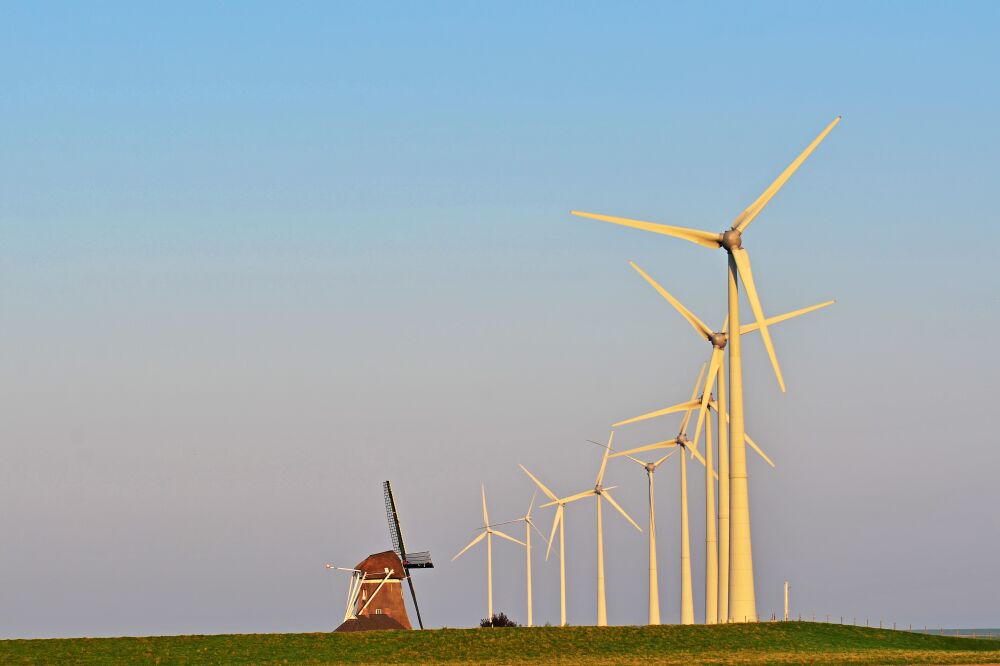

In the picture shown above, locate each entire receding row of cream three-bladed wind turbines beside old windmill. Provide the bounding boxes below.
[453,116,840,626]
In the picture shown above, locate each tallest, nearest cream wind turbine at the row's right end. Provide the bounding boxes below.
[571,116,840,622]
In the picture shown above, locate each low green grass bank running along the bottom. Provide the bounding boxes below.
[0,622,1000,664]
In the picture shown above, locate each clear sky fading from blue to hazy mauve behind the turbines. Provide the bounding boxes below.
[0,2,1000,638]
